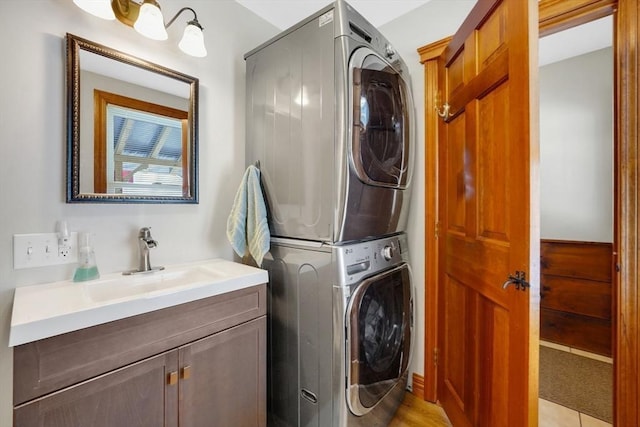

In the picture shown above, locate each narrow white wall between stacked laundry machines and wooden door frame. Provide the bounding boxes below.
[380,0,476,388]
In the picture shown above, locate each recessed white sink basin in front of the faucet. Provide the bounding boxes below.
[84,266,226,303]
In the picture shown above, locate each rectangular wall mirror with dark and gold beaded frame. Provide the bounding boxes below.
[66,34,198,203]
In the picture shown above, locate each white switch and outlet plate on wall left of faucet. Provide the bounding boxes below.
[13,232,78,270]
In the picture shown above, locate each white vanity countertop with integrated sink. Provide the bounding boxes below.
[9,259,269,347]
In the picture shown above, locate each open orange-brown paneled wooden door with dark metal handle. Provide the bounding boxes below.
[438,0,539,427]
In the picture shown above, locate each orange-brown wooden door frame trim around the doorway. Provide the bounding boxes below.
[418,0,640,426]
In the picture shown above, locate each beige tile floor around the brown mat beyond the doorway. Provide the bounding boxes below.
[538,341,613,427]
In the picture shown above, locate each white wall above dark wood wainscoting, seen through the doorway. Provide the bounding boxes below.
[540,48,613,242]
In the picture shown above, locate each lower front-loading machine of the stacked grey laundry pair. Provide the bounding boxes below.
[264,234,413,427]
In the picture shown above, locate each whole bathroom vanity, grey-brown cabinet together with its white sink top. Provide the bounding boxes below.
[10,260,268,427]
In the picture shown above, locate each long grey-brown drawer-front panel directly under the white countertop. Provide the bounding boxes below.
[13,285,266,406]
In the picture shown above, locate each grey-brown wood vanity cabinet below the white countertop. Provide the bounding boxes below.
[14,285,266,427]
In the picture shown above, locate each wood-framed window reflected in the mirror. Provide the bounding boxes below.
[94,90,189,197]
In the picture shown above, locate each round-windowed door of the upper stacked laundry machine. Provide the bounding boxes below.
[349,48,413,189]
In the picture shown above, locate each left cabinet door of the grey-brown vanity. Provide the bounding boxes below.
[14,351,178,427]
